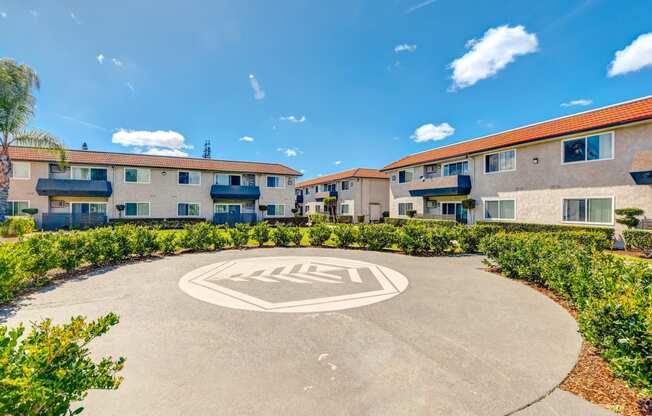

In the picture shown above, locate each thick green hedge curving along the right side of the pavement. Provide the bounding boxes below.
[480,233,652,394]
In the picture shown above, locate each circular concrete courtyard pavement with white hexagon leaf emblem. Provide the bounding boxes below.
[0,248,581,416]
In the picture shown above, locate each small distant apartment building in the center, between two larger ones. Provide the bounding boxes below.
[296,168,389,222]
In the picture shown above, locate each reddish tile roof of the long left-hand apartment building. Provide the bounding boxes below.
[9,146,301,176]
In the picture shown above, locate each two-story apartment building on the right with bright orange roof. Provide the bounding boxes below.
[382,97,652,237]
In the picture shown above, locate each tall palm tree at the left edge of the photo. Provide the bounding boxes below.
[0,58,66,221]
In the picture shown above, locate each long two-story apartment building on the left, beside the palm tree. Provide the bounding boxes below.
[8,147,301,229]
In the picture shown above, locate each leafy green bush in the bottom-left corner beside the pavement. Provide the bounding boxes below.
[0,313,125,415]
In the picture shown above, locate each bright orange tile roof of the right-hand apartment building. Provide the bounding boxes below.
[381,96,652,170]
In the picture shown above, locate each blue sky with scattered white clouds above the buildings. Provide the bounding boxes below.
[0,0,652,178]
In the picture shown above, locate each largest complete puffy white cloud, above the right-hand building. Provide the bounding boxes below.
[449,25,539,89]
